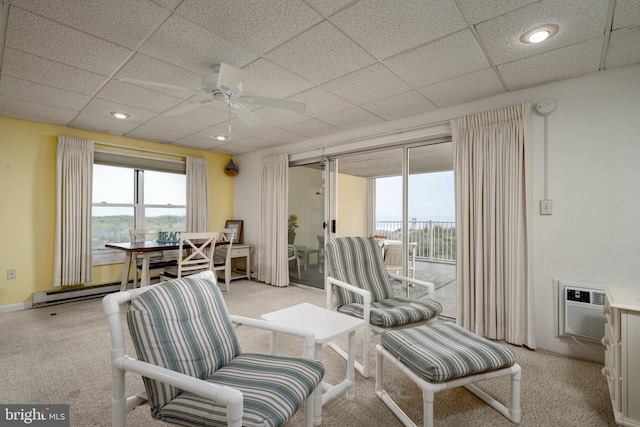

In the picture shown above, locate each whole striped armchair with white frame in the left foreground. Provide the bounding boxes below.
[103,271,324,427]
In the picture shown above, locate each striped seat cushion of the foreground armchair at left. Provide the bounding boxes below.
[159,353,324,427]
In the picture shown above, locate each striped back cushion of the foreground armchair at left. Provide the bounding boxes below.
[127,277,240,416]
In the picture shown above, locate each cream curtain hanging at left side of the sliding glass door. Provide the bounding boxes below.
[258,154,289,287]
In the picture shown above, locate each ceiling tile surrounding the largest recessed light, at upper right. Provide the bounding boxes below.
[477,0,609,65]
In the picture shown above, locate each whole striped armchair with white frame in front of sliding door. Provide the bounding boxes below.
[325,237,442,378]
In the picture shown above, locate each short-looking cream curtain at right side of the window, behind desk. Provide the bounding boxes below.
[187,156,209,233]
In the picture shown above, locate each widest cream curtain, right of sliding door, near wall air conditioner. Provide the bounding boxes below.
[451,103,536,348]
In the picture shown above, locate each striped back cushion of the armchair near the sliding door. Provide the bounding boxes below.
[325,237,393,307]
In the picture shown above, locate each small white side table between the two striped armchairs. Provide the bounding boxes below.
[260,302,364,425]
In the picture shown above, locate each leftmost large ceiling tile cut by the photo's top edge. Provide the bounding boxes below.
[11,0,170,49]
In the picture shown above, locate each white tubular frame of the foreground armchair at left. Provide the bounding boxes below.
[102,271,315,427]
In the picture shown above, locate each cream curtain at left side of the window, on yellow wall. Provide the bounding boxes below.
[53,135,94,286]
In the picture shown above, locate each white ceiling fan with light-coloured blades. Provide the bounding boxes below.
[119,63,306,127]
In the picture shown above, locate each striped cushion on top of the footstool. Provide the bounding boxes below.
[380,323,516,383]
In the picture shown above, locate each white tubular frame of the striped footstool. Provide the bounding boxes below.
[375,344,522,427]
